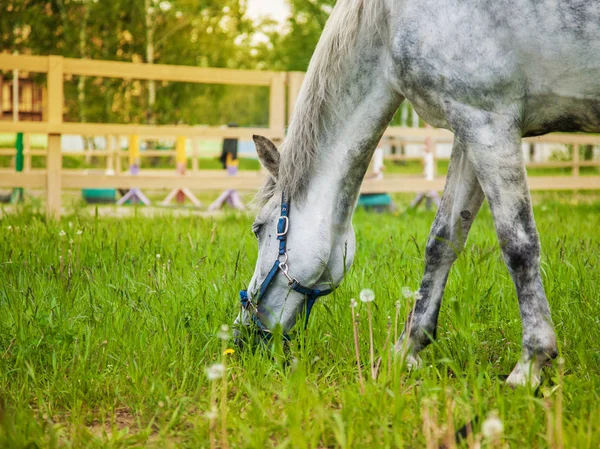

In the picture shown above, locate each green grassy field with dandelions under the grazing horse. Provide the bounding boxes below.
[0,194,600,448]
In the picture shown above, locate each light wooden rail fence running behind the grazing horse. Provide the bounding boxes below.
[0,54,600,217]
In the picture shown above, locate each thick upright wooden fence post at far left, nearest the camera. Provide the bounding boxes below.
[46,56,64,218]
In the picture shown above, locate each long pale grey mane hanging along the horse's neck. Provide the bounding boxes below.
[255,0,386,204]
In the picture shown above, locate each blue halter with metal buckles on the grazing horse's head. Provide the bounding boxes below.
[240,194,333,338]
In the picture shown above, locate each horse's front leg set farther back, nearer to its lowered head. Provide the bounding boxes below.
[396,138,484,367]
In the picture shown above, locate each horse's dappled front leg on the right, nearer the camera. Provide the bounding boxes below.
[467,120,557,386]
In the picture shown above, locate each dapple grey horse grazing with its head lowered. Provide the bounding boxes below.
[236,0,600,385]
